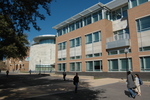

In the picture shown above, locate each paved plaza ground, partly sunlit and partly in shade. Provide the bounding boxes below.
[0,72,150,100]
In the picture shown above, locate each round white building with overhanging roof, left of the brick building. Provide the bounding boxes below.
[29,35,56,73]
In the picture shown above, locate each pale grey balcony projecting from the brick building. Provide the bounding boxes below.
[106,33,130,49]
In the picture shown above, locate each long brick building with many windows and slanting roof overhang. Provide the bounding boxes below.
[53,0,150,76]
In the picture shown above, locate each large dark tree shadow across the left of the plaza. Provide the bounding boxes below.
[0,74,106,100]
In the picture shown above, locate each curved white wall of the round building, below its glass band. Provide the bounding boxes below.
[29,44,55,70]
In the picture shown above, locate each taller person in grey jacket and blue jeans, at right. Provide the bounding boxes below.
[127,71,136,99]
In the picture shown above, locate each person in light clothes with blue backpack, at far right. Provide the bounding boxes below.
[134,74,141,96]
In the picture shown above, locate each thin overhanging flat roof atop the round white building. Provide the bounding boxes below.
[33,35,56,43]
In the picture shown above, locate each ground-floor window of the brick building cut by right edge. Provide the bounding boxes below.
[140,57,150,71]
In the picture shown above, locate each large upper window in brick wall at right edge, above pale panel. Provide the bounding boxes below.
[136,16,150,32]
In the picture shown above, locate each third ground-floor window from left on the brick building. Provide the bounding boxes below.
[86,60,102,72]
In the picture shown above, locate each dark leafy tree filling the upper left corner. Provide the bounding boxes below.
[0,0,52,59]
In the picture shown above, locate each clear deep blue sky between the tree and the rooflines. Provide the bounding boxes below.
[25,0,112,43]
